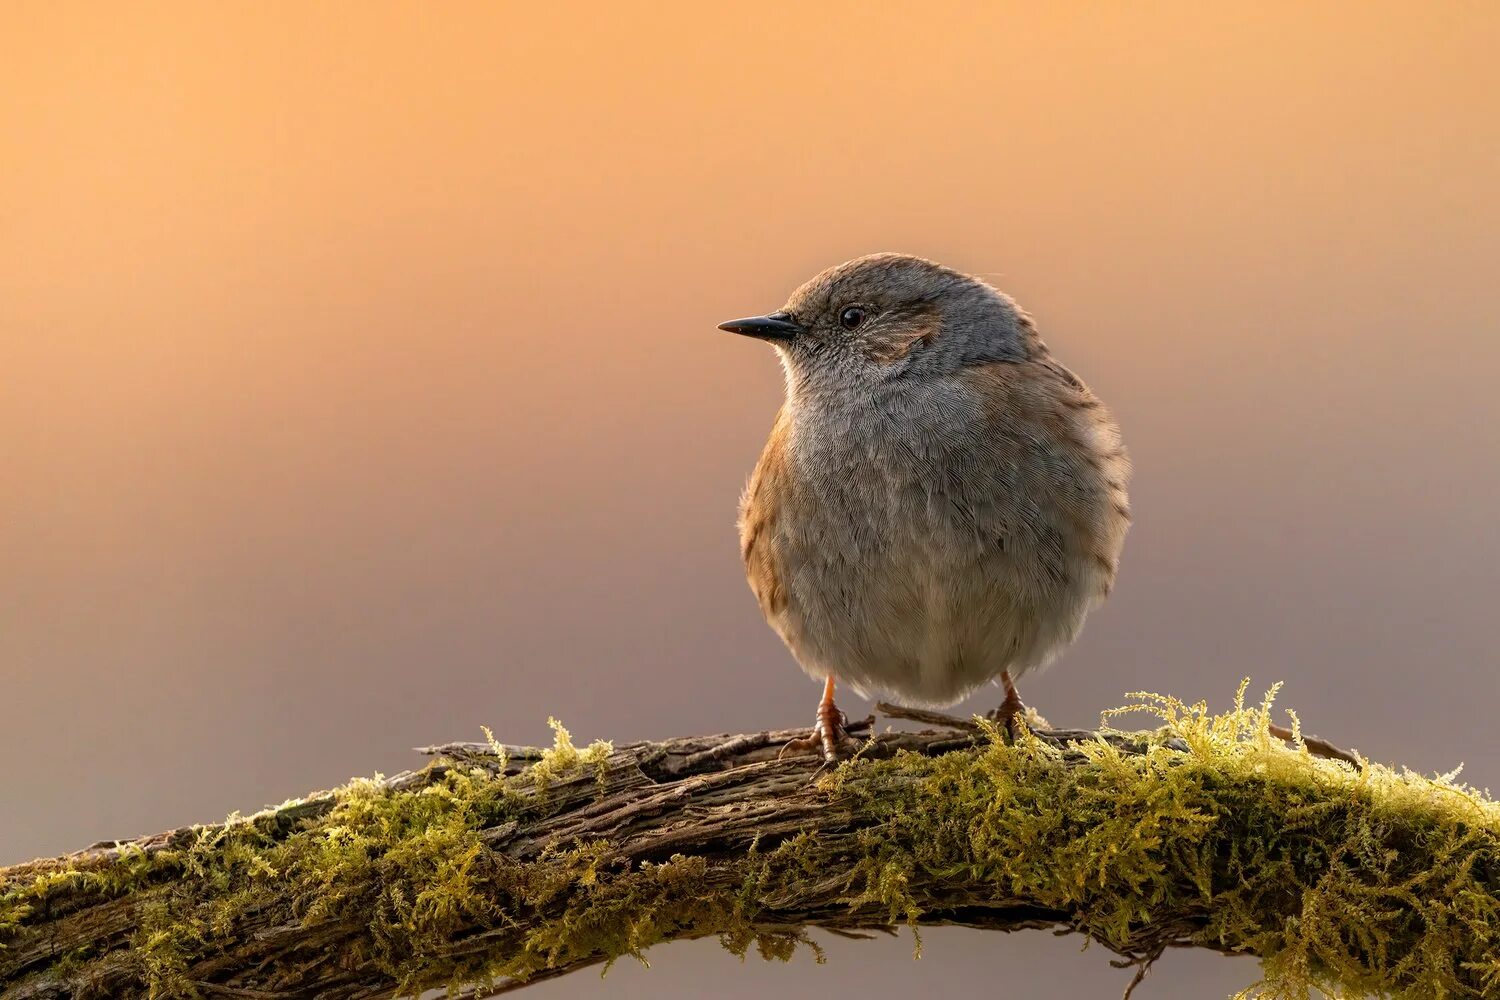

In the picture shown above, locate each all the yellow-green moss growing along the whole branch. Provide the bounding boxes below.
[0,687,1500,1000]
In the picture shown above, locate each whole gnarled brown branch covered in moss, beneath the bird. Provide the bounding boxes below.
[0,688,1500,1000]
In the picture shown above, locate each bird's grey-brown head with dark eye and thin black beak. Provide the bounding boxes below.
[719,253,1038,390]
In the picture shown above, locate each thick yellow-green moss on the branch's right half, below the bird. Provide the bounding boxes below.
[839,683,1500,999]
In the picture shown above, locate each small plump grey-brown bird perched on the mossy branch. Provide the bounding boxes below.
[719,253,1131,762]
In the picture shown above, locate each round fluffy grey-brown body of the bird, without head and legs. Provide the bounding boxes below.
[741,369,1128,705]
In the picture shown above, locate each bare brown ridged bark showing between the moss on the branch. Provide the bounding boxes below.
[0,706,1470,1000]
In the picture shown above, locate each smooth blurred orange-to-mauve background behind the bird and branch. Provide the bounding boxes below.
[0,0,1500,999]
